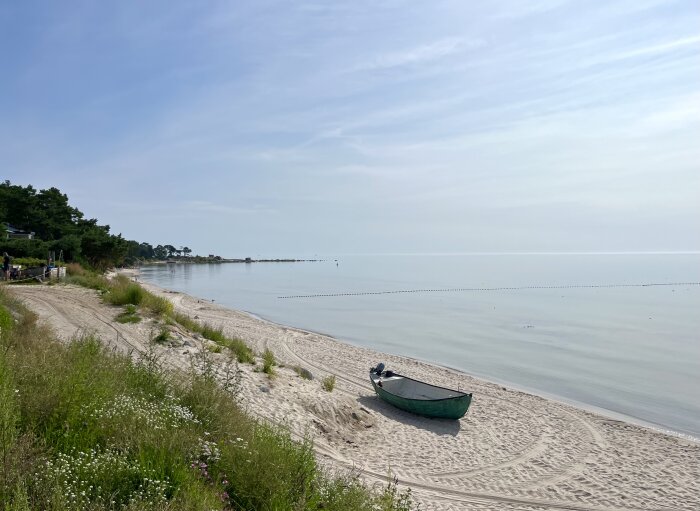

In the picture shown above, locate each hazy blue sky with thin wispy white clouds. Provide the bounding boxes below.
[0,0,700,257]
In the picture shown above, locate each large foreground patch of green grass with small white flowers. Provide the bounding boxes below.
[0,290,410,511]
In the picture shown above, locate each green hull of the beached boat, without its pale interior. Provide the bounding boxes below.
[370,371,472,419]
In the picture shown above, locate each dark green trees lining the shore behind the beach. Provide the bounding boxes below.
[0,181,192,269]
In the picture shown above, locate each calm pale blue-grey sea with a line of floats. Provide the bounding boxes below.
[141,253,700,438]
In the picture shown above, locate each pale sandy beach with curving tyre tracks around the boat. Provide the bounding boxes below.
[13,284,700,511]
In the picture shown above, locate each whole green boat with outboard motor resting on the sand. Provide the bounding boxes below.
[369,364,472,419]
